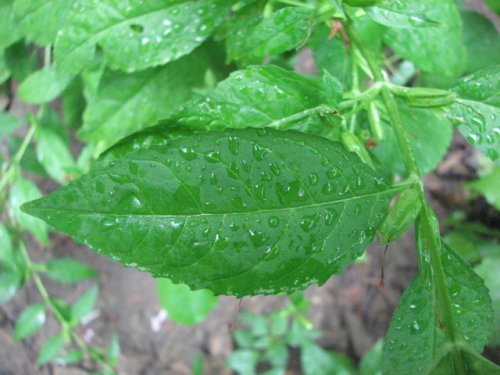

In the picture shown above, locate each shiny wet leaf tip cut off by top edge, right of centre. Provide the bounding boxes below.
[366,0,439,28]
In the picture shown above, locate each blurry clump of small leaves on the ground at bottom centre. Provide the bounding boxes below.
[227,293,355,375]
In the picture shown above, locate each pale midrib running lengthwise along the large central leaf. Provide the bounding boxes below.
[27,186,406,218]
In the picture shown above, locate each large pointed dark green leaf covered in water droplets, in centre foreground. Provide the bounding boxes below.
[23,129,398,296]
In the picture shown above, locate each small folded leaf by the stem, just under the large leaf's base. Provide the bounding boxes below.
[380,188,422,244]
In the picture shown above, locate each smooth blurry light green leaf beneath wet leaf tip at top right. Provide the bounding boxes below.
[384,0,466,77]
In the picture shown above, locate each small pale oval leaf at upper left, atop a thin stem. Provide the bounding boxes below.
[17,65,73,104]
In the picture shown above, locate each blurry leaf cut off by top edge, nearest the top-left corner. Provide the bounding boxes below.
[14,0,71,46]
